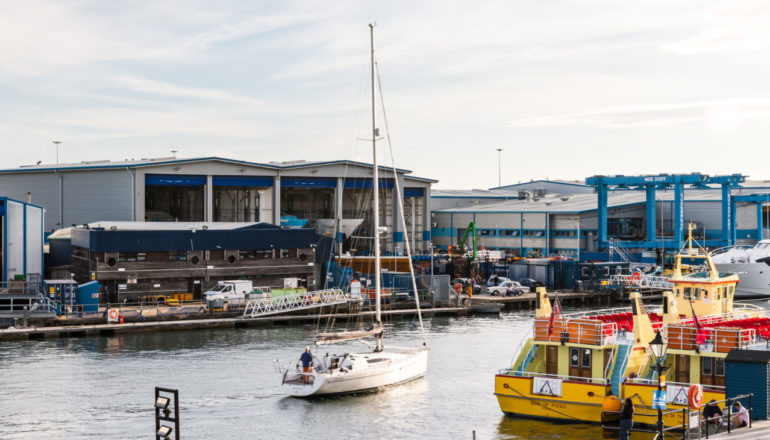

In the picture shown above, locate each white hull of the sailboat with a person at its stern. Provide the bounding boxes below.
[281,347,428,397]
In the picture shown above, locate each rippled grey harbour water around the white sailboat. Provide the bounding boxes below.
[9,300,752,440]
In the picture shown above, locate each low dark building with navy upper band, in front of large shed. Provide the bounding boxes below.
[71,222,331,303]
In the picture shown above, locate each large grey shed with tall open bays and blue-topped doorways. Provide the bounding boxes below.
[0,157,436,253]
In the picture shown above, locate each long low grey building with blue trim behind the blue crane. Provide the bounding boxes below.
[432,174,770,257]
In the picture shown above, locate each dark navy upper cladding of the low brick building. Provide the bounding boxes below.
[72,228,318,252]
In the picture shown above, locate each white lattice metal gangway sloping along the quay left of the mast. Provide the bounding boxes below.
[242,289,350,318]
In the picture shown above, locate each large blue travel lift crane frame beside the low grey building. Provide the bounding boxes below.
[586,173,744,250]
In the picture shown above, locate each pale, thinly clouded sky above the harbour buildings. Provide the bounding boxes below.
[0,0,770,189]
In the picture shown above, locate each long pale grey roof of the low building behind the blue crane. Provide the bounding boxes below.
[439,188,770,213]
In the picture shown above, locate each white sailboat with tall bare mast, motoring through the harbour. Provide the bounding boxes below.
[279,24,428,397]
